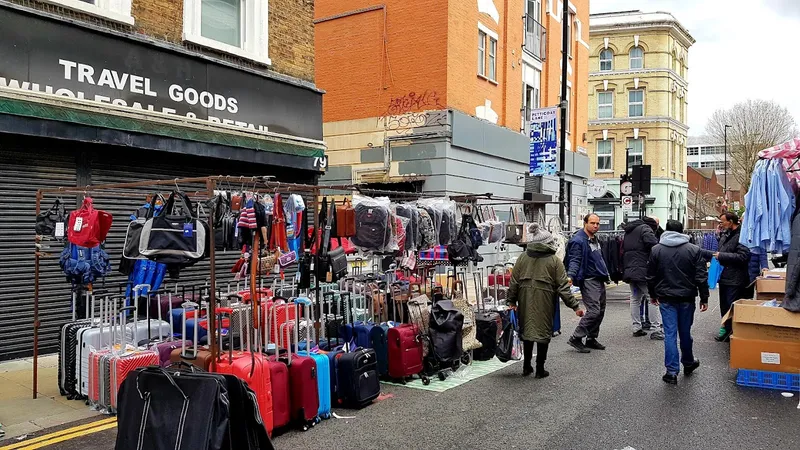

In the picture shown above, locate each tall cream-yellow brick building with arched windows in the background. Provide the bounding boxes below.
[586,11,695,229]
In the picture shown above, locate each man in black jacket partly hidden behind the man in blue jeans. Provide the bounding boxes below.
[622,219,664,339]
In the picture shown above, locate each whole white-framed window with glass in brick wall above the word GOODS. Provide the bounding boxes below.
[183,0,271,64]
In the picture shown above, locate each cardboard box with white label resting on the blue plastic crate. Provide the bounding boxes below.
[730,335,800,373]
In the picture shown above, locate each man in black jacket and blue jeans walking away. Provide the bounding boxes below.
[647,220,708,384]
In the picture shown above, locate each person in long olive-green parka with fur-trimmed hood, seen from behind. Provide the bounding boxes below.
[508,223,583,378]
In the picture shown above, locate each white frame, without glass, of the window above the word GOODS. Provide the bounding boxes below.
[183,0,272,65]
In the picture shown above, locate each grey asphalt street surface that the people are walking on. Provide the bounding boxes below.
[0,287,800,450]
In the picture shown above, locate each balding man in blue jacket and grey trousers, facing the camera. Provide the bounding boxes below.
[565,213,609,353]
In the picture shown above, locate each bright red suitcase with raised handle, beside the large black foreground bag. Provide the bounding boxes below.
[214,304,273,434]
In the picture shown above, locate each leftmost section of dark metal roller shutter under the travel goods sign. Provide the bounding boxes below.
[0,137,77,360]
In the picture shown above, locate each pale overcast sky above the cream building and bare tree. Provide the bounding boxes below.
[590,0,800,136]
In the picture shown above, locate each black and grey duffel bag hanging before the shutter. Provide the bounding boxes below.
[139,192,209,266]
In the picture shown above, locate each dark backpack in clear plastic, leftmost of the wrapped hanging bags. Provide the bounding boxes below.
[350,195,392,253]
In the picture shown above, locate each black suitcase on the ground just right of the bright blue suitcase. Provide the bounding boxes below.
[336,348,381,408]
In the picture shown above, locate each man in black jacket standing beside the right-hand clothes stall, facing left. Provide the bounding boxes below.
[714,212,750,342]
